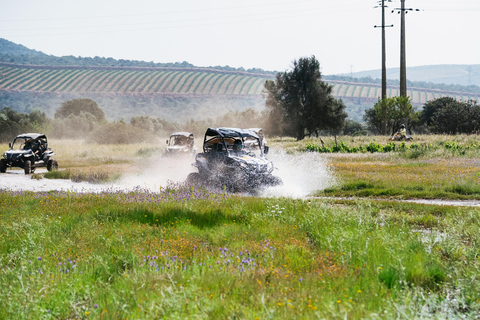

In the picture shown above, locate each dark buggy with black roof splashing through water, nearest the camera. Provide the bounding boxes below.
[186,128,282,192]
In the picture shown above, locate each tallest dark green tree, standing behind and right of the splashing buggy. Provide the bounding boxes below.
[264,56,347,140]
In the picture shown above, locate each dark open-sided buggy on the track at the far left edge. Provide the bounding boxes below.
[0,133,58,174]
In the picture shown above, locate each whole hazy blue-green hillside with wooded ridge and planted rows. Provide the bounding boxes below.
[0,39,480,121]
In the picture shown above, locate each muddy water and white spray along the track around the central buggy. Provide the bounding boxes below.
[0,150,480,207]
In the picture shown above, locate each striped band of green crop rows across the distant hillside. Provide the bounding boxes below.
[0,63,479,105]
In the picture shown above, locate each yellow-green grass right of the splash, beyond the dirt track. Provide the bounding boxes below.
[269,135,480,200]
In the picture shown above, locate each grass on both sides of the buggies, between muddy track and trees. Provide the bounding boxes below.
[0,135,480,200]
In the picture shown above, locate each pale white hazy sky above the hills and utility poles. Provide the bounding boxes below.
[0,0,480,74]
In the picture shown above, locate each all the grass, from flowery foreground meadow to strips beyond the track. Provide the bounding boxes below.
[0,136,480,319]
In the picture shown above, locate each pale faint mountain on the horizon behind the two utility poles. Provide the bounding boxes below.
[341,64,480,86]
